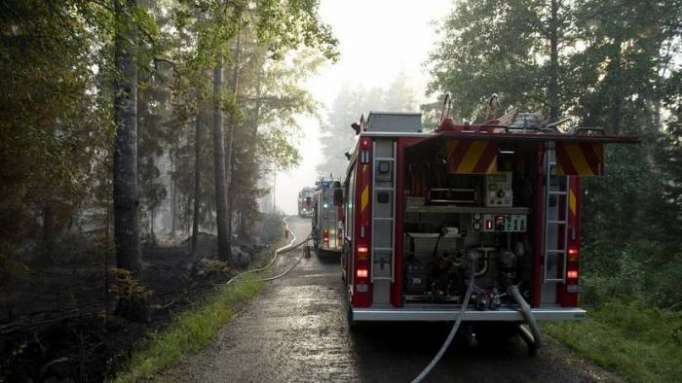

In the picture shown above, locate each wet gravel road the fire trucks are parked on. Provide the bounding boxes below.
[158,218,619,382]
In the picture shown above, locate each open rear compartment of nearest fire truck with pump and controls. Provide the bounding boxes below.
[402,144,537,311]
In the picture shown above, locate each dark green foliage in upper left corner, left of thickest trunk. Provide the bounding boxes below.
[0,1,112,256]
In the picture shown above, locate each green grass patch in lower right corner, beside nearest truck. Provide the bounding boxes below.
[544,301,682,382]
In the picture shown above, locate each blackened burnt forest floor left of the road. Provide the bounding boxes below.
[0,234,266,383]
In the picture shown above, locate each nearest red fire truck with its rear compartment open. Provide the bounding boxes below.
[342,113,638,332]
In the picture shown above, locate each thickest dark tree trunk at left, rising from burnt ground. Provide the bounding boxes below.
[113,0,140,275]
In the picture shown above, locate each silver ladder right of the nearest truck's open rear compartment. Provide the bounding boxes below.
[543,142,568,283]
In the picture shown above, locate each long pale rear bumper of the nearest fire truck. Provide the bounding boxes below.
[351,308,586,322]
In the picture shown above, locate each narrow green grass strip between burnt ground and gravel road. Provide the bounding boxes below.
[114,274,264,383]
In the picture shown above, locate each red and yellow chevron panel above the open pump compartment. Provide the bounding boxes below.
[448,140,497,174]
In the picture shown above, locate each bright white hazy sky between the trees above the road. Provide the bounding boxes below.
[276,0,452,214]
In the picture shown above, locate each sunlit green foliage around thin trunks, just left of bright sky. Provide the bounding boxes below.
[168,0,337,234]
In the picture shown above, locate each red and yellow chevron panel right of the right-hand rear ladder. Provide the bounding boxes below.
[556,142,604,176]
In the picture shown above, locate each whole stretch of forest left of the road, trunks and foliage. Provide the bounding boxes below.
[0,0,338,381]
